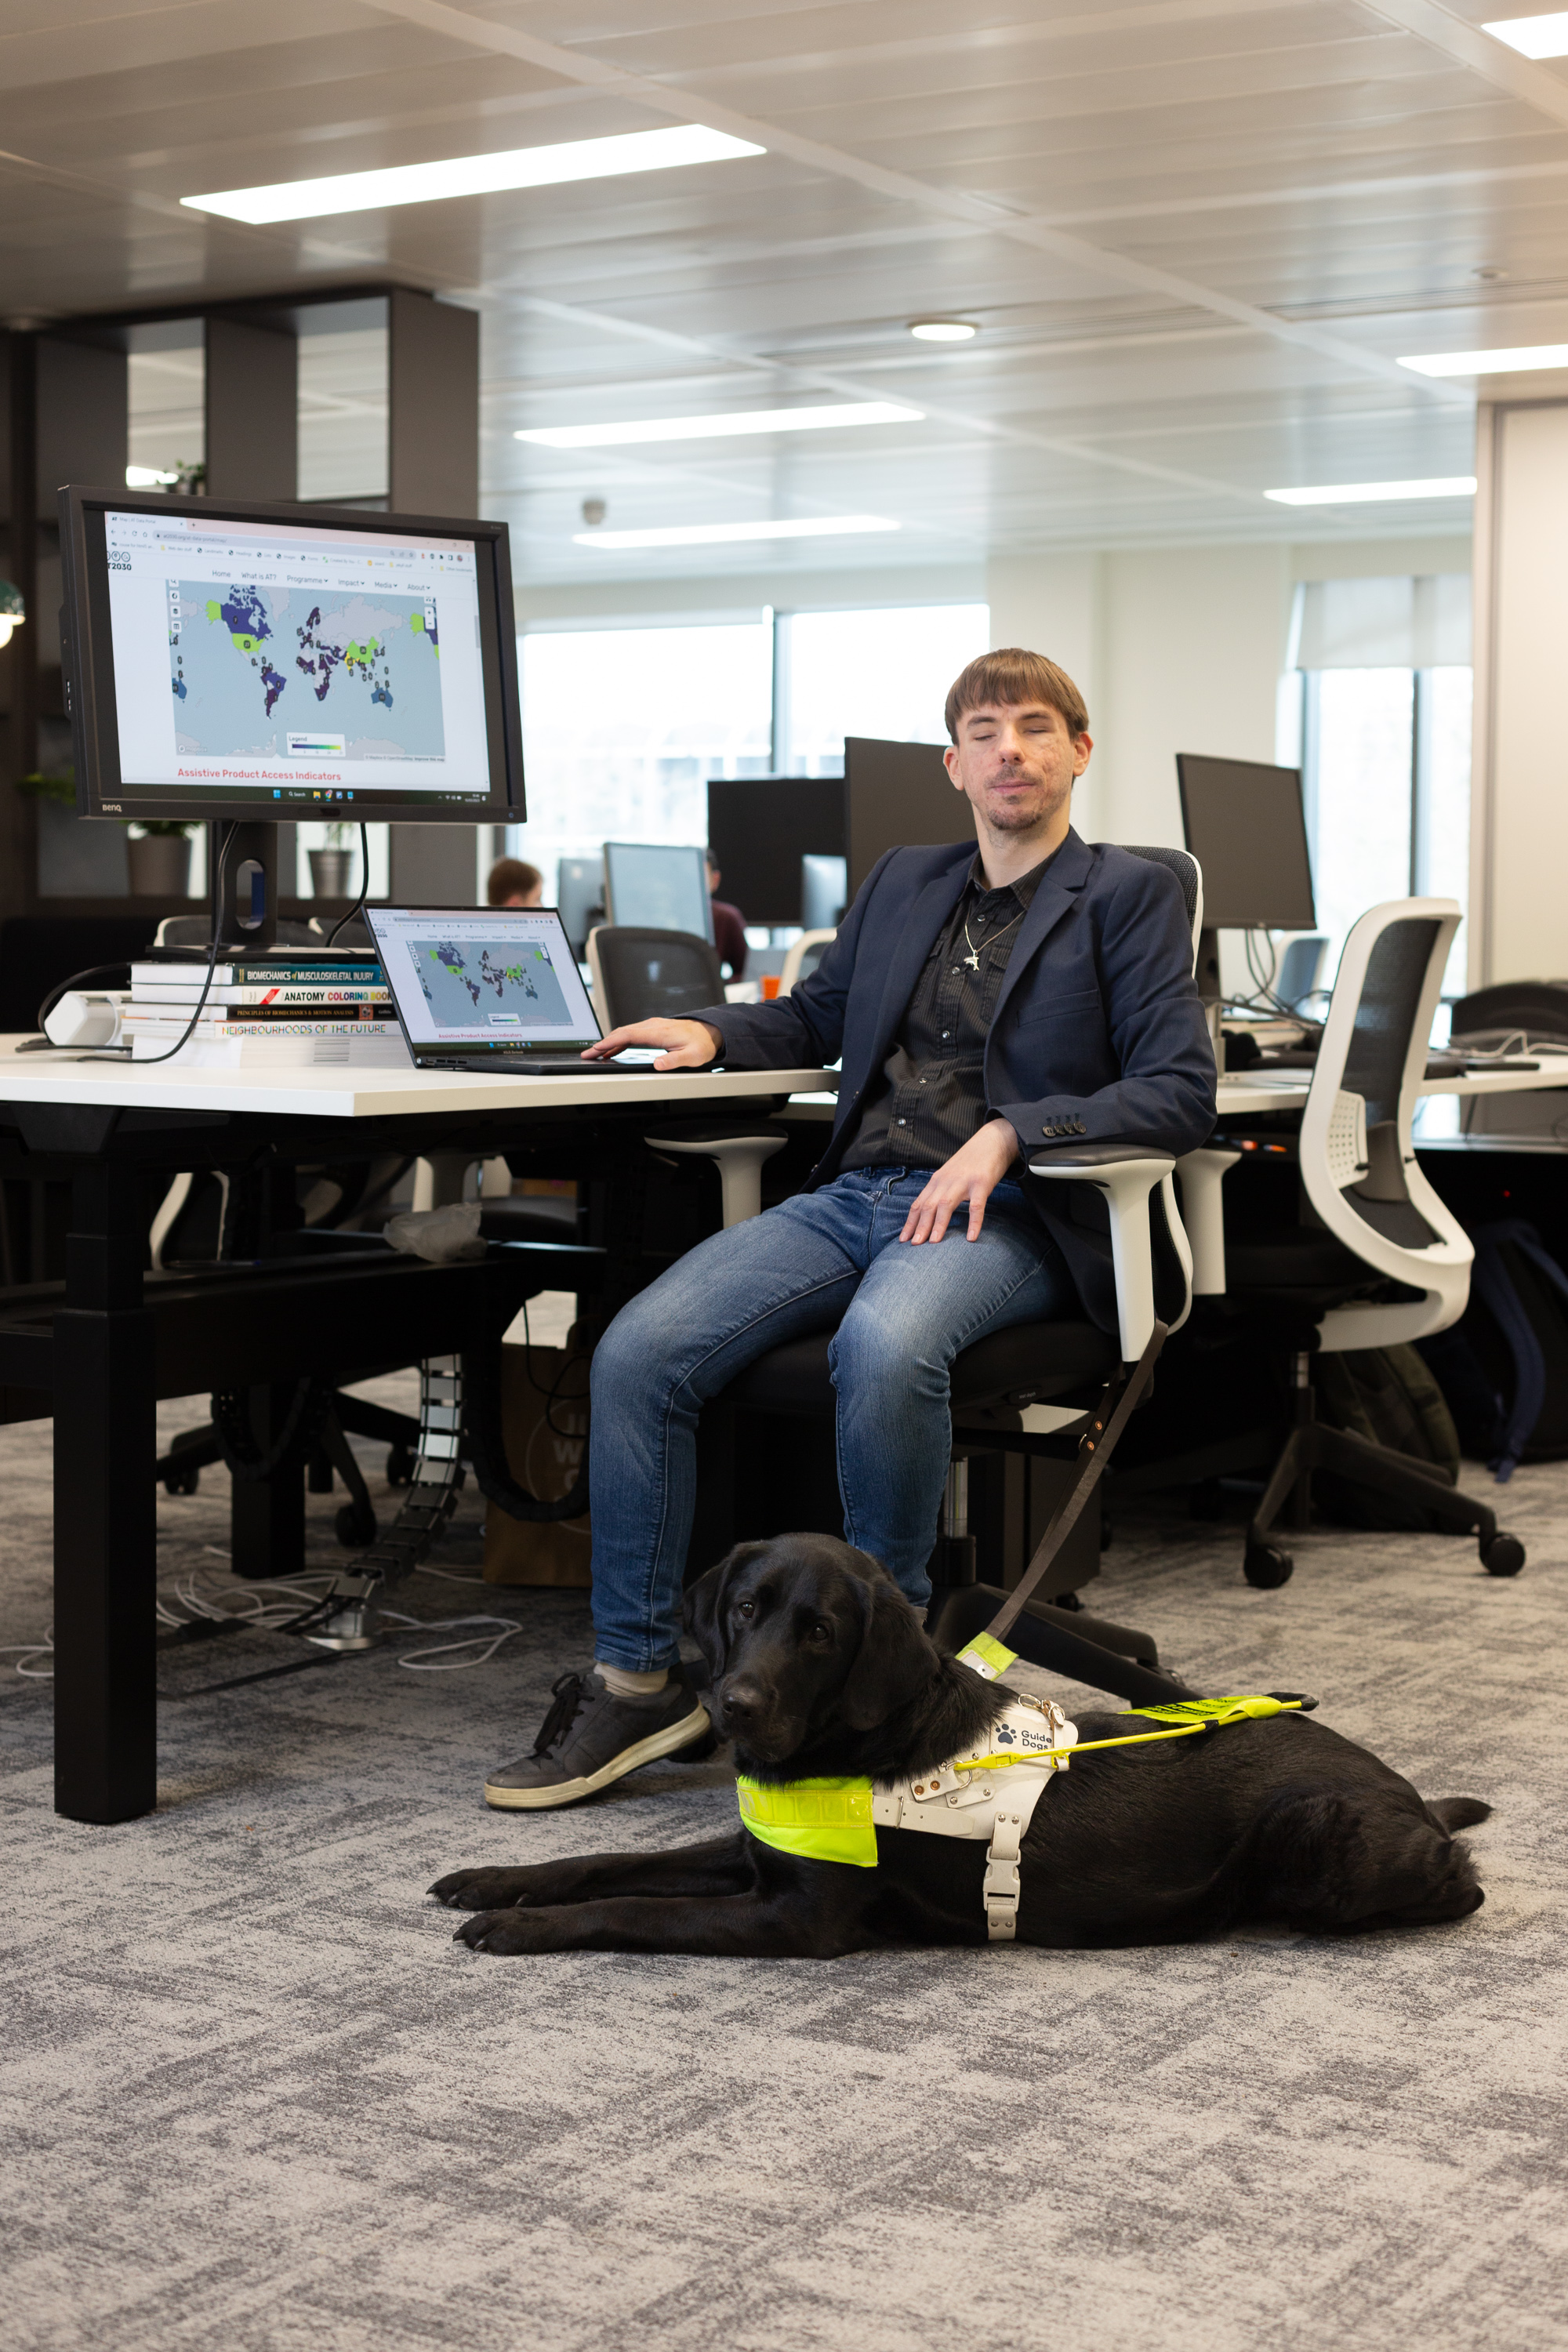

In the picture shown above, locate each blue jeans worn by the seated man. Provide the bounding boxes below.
[590,1167,1081,1672]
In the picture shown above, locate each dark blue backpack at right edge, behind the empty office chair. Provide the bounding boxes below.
[1420,1218,1568,1482]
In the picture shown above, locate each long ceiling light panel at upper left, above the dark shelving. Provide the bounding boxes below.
[181,122,767,223]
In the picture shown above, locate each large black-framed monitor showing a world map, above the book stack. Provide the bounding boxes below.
[59,489,527,823]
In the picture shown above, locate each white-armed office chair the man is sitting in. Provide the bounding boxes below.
[691,849,1203,1705]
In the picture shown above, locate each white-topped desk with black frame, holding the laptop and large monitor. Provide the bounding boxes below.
[0,1037,837,1823]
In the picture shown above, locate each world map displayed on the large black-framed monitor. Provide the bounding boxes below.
[169,581,447,760]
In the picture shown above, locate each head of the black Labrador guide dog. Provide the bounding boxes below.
[687,1536,940,1764]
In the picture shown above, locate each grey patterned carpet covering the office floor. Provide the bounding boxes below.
[0,1374,1568,2352]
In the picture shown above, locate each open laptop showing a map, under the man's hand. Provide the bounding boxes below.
[365,906,677,1077]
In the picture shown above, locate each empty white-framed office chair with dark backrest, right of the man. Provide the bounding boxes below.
[1194,898,1526,1588]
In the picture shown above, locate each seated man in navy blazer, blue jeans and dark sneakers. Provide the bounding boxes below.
[485,649,1215,1809]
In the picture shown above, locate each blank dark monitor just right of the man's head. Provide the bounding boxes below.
[1175,750,1316,931]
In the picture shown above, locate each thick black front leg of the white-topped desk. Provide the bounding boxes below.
[54,1162,158,1823]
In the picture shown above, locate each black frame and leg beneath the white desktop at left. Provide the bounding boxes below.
[0,1096,787,1823]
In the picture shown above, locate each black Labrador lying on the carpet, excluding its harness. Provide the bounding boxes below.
[430,1536,1490,1959]
